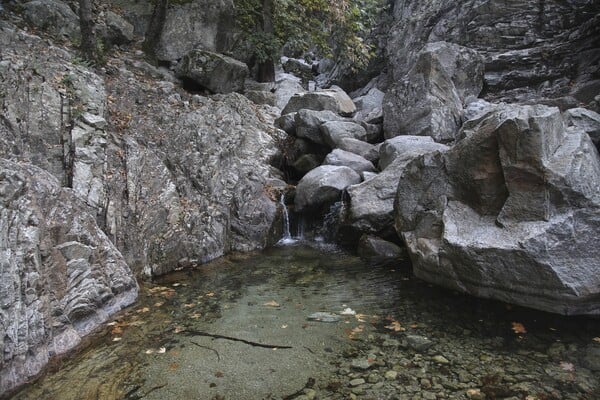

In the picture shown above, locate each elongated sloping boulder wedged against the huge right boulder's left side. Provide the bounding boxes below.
[346,137,448,236]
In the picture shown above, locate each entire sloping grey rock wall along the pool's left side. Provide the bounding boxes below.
[0,21,285,392]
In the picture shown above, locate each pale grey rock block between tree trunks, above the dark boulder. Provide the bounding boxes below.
[156,0,235,62]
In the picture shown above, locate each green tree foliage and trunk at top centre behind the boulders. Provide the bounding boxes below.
[234,0,386,78]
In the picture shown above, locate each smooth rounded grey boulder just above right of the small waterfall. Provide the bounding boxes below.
[294,165,361,211]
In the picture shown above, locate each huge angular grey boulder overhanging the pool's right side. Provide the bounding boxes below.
[395,105,600,314]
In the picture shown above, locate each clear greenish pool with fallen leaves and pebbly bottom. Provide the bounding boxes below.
[14,244,600,400]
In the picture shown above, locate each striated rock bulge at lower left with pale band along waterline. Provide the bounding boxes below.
[0,159,138,393]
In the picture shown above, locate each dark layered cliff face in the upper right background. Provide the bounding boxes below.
[386,0,600,104]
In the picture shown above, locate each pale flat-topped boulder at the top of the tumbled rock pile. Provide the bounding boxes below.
[281,86,356,117]
